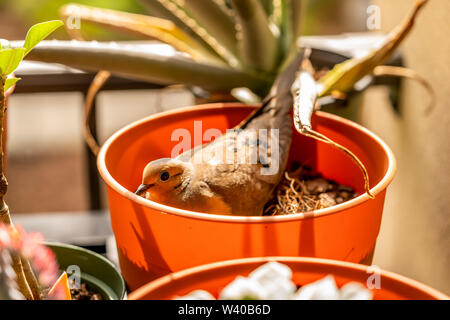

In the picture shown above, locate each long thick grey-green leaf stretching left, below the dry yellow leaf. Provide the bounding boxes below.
[27,41,270,92]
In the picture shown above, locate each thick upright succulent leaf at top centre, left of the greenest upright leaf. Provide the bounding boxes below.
[231,0,279,72]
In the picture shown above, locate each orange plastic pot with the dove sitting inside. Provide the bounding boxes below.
[98,103,396,290]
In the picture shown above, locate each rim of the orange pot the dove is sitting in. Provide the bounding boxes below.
[97,103,397,223]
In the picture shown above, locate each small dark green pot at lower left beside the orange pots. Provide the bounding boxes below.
[45,242,126,300]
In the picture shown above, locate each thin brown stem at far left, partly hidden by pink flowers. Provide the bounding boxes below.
[0,76,41,300]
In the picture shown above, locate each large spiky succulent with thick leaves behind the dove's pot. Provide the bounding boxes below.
[19,0,427,97]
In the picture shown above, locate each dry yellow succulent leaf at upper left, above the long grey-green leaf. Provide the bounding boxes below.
[60,4,223,63]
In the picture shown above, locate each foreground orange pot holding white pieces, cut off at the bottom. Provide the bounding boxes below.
[128,257,449,300]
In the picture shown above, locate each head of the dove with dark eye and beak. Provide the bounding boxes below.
[136,158,192,203]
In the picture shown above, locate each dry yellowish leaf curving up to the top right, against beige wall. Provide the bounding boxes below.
[319,0,428,96]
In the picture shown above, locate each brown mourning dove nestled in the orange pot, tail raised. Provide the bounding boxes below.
[136,52,304,216]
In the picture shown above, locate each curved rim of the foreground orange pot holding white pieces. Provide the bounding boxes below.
[128,257,450,300]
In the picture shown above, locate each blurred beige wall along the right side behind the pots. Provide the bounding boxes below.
[360,0,450,294]
